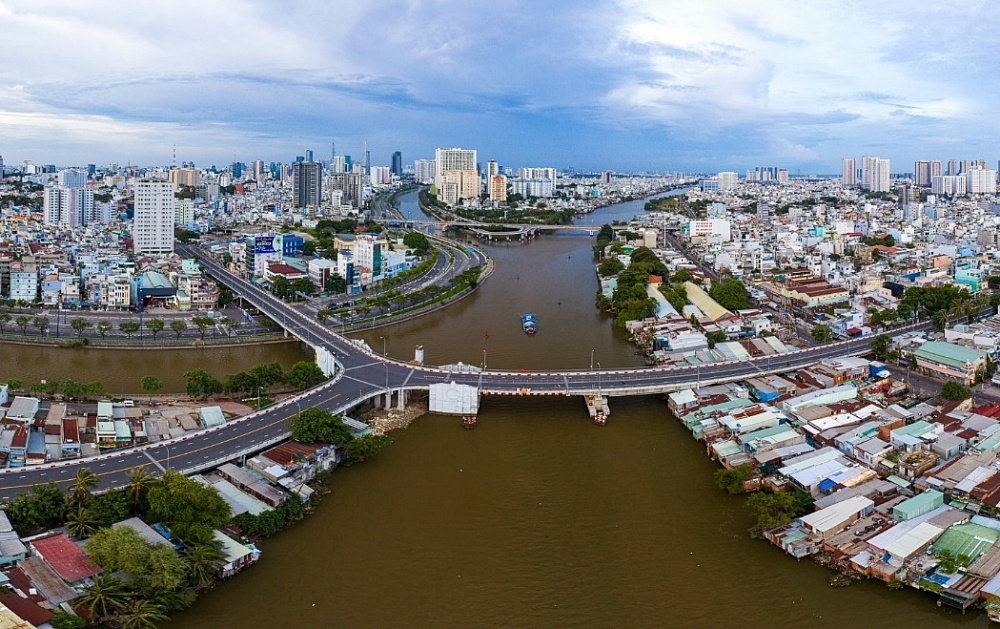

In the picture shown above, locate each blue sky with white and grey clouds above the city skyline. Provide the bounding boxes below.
[0,0,1000,175]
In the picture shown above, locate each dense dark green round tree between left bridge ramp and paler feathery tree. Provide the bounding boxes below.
[147,470,230,543]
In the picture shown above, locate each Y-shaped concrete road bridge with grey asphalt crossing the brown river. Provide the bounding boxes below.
[0,246,929,500]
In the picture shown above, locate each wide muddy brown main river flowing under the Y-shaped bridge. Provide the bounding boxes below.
[5,189,988,629]
